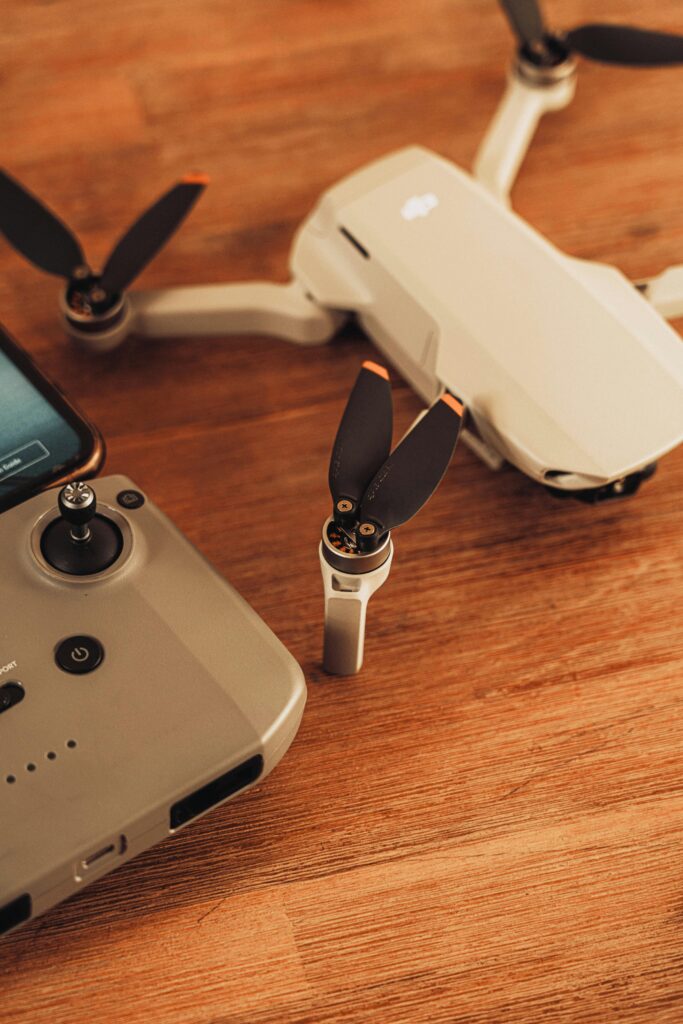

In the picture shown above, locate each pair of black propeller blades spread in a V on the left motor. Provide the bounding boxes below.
[0,169,208,316]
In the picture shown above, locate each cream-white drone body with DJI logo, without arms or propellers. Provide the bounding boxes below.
[292,146,683,493]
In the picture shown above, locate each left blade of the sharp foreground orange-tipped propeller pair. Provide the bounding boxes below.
[329,361,393,522]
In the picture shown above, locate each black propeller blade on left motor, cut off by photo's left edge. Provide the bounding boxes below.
[0,170,85,281]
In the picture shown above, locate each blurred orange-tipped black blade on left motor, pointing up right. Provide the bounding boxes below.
[99,174,209,295]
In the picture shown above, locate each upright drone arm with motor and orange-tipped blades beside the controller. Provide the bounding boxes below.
[319,362,464,676]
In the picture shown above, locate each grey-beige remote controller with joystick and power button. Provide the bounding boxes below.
[0,476,306,934]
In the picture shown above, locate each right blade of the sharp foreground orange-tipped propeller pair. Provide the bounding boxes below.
[358,393,464,547]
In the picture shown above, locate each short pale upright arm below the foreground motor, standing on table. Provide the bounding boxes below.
[319,542,393,676]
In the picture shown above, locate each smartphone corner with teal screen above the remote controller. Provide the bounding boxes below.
[0,326,104,512]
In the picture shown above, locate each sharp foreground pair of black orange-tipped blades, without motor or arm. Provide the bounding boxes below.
[330,362,464,553]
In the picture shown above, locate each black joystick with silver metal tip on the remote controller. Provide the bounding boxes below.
[40,482,123,577]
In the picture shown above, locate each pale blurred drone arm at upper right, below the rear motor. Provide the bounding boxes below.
[473,69,575,204]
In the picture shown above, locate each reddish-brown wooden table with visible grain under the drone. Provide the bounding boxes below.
[0,0,683,1024]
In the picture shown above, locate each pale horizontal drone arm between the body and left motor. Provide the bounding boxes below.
[130,281,345,345]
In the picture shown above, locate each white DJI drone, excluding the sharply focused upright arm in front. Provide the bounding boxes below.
[0,0,683,503]
